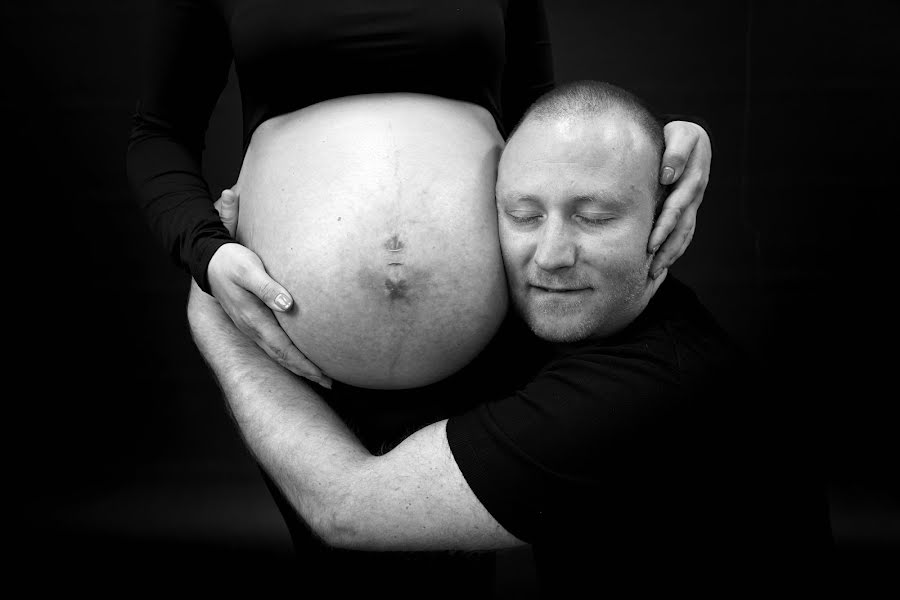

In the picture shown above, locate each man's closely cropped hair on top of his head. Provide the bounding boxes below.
[507,79,669,214]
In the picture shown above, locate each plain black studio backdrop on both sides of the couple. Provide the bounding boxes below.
[0,0,900,597]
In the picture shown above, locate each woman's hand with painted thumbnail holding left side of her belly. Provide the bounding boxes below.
[207,190,331,388]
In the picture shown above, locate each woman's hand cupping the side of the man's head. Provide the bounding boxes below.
[647,121,712,279]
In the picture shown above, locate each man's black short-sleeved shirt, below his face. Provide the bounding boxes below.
[447,276,828,597]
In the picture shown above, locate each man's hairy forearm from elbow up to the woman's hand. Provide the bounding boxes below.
[188,289,372,541]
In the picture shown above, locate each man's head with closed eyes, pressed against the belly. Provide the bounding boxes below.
[497,81,665,343]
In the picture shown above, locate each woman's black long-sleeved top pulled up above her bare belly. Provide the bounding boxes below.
[127,0,553,291]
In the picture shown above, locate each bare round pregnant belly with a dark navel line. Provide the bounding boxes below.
[236,94,507,389]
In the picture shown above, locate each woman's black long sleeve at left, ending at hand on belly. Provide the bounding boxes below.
[126,0,234,292]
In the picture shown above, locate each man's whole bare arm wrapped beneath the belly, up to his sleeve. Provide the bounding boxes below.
[188,284,524,550]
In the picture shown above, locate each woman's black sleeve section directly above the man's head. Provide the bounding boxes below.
[501,0,554,136]
